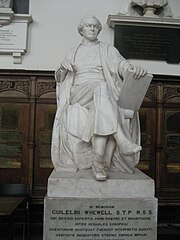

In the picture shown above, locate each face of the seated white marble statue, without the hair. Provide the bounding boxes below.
[82,17,99,41]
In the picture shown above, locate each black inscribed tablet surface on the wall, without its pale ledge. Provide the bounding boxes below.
[115,26,180,63]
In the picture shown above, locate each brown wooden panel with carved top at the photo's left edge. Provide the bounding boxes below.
[0,76,31,183]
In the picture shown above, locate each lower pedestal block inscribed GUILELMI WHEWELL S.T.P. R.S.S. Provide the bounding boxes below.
[44,198,157,240]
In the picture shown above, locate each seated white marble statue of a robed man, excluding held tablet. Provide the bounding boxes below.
[51,16,146,180]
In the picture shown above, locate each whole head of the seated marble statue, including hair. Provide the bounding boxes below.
[77,15,102,40]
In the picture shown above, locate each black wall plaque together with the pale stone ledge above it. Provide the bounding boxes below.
[108,15,180,64]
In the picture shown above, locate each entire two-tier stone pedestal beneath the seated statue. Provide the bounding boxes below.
[43,169,157,240]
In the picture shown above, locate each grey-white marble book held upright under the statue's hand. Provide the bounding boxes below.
[118,71,153,112]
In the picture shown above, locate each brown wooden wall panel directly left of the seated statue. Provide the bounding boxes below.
[34,103,56,193]
